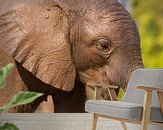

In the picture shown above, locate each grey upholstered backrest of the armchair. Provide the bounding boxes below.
[123,69,163,106]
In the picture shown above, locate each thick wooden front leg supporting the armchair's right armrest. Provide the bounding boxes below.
[141,91,152,130]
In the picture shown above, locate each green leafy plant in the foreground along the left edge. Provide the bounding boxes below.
[0,64,43,130]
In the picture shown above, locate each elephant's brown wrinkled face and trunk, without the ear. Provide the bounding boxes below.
[71,0,143,87]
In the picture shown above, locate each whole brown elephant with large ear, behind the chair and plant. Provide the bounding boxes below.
[0,0,143,112]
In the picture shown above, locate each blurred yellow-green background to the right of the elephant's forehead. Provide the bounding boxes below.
[119,0,163,68]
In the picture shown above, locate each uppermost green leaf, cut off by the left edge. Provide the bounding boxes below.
[0,64,14,89]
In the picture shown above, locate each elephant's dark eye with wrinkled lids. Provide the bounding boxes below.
[96,39,111,51]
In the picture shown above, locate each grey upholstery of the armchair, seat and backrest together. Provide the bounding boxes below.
[85,69,163,122]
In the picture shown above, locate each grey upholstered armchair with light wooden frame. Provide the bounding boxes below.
[85,69,163,130]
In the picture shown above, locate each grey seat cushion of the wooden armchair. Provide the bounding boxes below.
[85,100,163,122]
